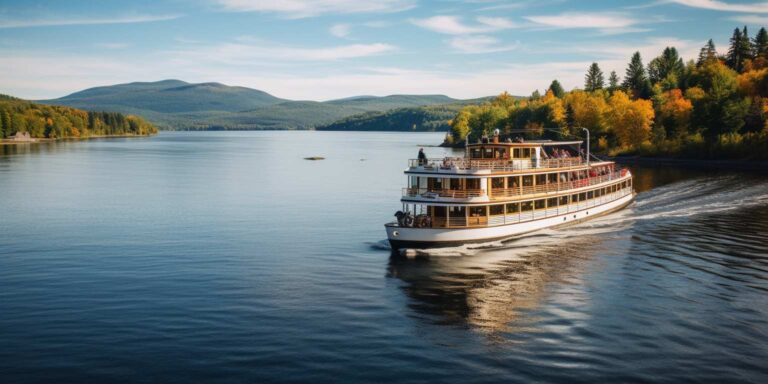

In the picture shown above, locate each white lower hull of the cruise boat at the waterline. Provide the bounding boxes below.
[385,192,635,249]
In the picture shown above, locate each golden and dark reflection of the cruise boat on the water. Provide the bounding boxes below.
[388,230,606,334]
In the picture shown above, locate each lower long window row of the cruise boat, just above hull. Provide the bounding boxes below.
[428,180,632,217]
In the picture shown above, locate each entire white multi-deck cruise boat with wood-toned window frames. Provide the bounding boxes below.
[385,131,635,249]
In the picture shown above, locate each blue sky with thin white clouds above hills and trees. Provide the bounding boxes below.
[0,0,768,100]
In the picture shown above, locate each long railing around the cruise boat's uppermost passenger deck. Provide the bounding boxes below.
[408,157,585,172]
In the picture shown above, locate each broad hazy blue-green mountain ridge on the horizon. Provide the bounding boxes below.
[39,80,486,130]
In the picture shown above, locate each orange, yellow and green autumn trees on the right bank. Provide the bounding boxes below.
[445,26,768,159]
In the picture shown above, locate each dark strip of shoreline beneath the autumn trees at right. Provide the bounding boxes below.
[602,156,768,173]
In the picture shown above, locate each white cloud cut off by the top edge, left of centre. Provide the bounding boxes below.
[216,0,415,18]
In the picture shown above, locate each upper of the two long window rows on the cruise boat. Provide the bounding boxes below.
[410,166,613,190]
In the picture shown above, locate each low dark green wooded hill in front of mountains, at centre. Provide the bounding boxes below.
[316,98,490,132]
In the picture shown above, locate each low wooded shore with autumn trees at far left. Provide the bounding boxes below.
[0,95,157,139]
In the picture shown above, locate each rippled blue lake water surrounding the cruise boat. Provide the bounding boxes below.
[0,132,768,383]
